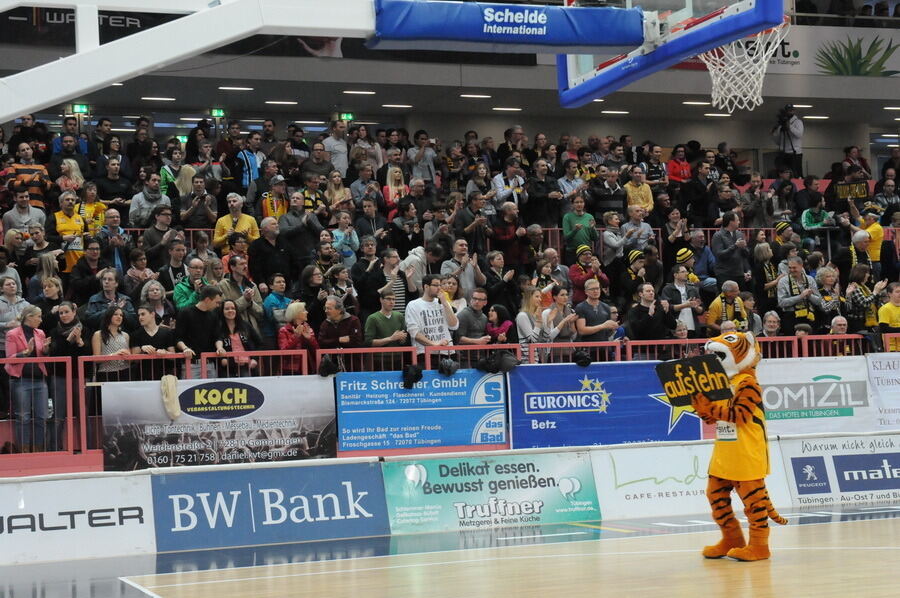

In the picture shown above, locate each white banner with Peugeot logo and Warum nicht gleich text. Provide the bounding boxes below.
[780,434,900,506]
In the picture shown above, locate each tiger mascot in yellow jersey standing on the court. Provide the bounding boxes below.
[691,332,787,561]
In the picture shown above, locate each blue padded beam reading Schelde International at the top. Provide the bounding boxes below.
[368,0,644,52]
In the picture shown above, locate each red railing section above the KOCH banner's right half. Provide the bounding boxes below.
[199,349,309,378]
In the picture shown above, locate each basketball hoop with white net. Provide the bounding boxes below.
[697,16,790,112]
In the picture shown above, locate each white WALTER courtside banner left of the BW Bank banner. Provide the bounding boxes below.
[0,475,156,565]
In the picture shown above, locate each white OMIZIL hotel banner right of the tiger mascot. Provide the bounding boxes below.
[756,356,877,435]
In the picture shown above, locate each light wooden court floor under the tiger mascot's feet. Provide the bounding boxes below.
[123,518,900,598]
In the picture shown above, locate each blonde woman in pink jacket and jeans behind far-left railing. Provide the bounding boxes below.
[6,305,50,453]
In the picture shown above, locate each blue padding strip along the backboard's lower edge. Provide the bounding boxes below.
[556,1,784,108]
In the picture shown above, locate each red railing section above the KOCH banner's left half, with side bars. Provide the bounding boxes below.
[77,353,198,450]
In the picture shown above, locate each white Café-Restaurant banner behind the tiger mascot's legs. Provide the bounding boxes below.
[591,441,791,519]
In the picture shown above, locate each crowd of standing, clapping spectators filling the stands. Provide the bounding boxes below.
[0,116,900,450]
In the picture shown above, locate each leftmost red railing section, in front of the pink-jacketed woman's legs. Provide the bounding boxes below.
[0,357,76,458]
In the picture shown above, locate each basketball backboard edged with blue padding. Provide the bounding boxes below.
[557,0,784,108]
